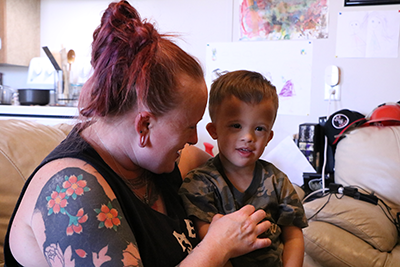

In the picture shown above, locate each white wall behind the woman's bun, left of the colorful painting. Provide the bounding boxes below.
[41,0,233,153]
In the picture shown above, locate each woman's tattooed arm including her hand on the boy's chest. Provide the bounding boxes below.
[10,159,271,267]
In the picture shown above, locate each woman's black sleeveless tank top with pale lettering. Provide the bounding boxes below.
[4,128,199,267]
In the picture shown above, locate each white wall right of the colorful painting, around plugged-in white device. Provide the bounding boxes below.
[269,0,400,154]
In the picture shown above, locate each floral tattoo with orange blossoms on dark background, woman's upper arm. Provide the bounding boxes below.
[36,168,142,267]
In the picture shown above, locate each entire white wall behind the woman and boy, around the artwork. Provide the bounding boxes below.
[0,0,400,156]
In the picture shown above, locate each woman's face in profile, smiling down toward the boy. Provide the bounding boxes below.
[139,75,207,173]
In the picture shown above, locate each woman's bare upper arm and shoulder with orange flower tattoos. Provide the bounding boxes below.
[10,159,142,266]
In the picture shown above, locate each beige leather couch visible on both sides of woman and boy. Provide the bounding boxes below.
[0,120,400,267]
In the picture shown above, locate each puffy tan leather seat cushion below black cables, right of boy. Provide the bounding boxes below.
[304,195,398,252]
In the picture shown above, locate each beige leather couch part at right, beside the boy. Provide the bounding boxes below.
[303,126,400,267]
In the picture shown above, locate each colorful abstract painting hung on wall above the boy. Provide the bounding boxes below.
[239,0,328,40]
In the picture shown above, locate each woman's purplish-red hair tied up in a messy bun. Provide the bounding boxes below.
[79,1,203,118]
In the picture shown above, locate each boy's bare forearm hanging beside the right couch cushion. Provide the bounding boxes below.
[282,226,304,267]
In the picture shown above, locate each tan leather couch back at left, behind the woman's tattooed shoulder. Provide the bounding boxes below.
[0,120,72,266]
